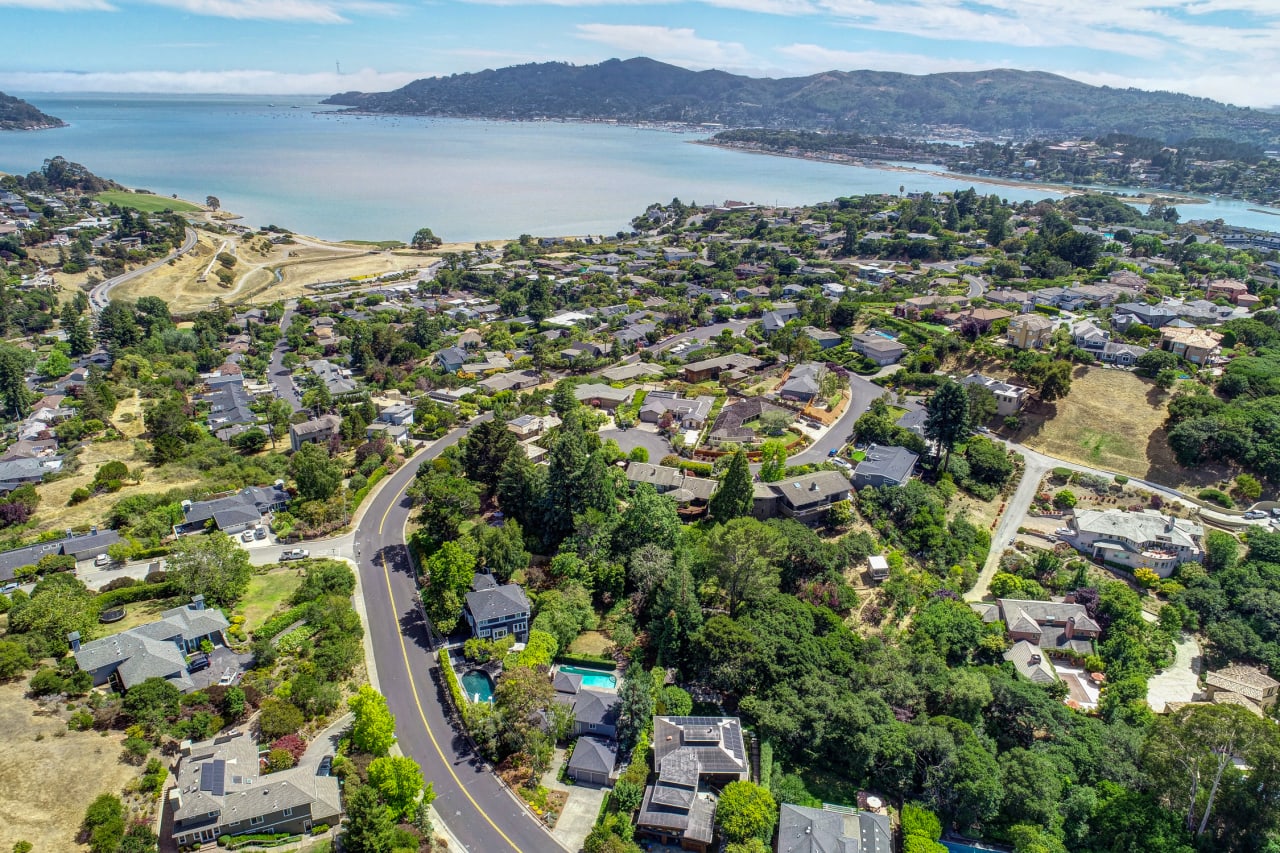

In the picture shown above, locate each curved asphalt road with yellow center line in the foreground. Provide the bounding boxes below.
[355,427,564,853]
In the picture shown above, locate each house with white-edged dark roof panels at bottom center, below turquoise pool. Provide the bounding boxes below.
[636,717,750,853]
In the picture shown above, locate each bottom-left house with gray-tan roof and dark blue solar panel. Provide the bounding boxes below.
[168,733,342,848]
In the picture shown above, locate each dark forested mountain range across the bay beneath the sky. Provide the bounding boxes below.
[325,58,1280,146]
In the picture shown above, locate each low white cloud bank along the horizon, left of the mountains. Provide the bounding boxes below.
[0,68,428,95]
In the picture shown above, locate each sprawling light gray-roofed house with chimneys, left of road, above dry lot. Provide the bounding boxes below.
[74,596,230,693]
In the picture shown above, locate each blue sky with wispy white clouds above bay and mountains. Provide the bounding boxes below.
[0,0,1280,106]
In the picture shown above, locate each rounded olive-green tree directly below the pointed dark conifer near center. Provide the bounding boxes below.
[703,519,782,617]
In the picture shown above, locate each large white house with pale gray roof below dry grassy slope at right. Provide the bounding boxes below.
[1070,510,1204,578]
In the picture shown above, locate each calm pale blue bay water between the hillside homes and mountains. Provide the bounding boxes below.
[0,93,1280,241]
